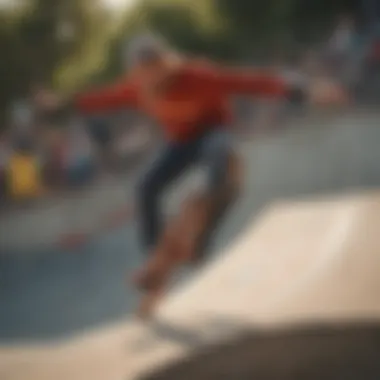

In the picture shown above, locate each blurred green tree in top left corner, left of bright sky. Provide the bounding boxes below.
[0,0,113,117]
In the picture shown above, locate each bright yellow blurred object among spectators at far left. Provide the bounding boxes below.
[8,153,43,200]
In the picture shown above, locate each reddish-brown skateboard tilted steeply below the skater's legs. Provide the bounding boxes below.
[134,153,242,319]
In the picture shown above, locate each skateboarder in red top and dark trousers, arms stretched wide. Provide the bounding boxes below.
[37,36,348,284]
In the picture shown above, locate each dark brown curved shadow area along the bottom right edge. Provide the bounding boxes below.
[139,322,380,380]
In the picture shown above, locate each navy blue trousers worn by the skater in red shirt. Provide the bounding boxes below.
[137,129,231,251]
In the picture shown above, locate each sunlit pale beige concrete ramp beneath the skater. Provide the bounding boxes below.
[0,194,380,380]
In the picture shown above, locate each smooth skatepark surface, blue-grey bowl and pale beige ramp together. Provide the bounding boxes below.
[0,109,380,380]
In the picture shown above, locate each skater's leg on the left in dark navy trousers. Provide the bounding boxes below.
[137,144,196,251]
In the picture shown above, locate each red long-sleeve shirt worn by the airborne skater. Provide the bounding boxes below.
[76,63,288,141]
